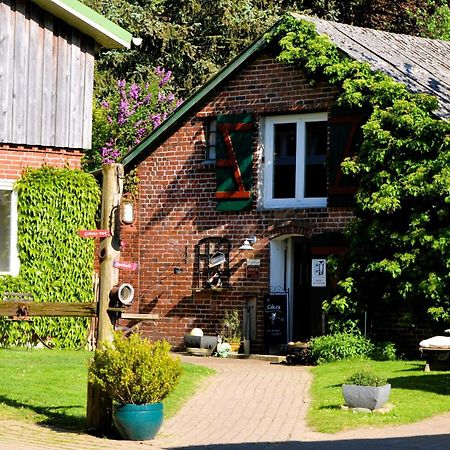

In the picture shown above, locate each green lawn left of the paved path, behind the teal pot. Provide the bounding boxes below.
[0,349,214,430]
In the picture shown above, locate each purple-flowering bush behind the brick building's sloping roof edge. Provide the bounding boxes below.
[85,67,182,170]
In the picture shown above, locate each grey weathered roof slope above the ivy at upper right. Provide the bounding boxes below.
[293,14,450,117]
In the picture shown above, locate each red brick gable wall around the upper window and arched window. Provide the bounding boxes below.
[121,51,352,348]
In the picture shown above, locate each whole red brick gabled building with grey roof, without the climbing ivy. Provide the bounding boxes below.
[123,17,450,352]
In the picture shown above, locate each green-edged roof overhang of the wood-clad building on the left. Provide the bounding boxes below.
[32,0,131,48]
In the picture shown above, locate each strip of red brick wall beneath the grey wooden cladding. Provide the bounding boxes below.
[0,143,83,180]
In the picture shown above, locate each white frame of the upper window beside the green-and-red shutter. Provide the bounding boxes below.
[263,113,328,208]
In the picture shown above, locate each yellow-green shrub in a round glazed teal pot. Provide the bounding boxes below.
[88,333,182,441]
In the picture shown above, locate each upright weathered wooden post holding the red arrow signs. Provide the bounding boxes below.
[86,164,124,435]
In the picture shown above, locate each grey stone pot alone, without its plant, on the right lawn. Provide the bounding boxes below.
[342,384,391,410]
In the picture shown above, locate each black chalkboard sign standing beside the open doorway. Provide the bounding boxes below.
[264,292,288,349]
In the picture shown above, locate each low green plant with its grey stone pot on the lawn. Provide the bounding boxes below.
[342,370,391,411]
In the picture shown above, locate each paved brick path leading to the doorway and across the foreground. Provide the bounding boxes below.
[0,357,450,450]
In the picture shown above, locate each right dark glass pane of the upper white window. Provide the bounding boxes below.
[304,122,327,198]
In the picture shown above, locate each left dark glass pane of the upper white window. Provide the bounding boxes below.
[273,123,297,198]
